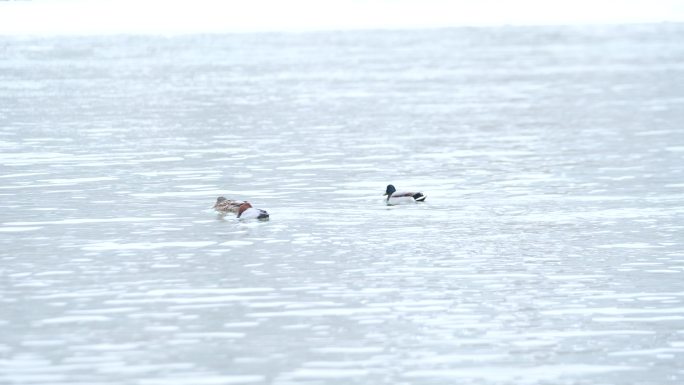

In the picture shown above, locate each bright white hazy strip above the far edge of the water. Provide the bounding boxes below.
[0,0,684,34]
